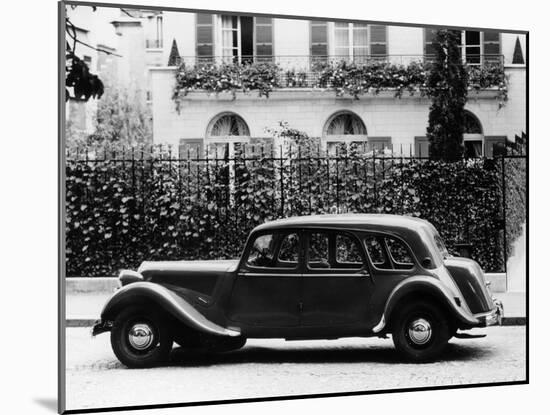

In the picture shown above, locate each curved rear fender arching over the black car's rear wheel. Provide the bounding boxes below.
[372,275,479,333]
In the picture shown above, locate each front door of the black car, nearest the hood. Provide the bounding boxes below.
[228,230,302,328]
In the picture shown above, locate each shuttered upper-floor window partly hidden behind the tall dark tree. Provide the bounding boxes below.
[424,28,501,65]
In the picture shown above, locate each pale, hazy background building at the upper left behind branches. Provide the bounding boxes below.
[66,5,162,135]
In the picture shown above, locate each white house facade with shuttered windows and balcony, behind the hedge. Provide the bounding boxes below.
[143,12,526,157]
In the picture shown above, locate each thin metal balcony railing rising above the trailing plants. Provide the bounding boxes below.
[175,55,504,92]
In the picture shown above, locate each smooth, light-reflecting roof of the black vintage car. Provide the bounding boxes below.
[254,213,431,231]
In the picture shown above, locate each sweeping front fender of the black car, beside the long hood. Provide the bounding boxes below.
[96,282,240,337]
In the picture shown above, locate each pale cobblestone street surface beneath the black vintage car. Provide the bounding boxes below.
[66,326,526,409]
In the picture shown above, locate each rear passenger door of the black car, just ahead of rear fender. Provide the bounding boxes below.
[301,230,373,328]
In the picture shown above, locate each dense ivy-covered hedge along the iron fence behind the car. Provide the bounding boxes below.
[66,151,525,277]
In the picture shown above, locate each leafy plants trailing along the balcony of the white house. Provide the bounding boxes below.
[172,61,508,106]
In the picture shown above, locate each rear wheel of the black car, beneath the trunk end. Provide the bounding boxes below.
[392,301,450,362]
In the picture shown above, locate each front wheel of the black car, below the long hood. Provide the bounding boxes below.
[111,307,172,368]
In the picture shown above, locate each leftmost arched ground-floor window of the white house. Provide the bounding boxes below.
[205,112,250,157]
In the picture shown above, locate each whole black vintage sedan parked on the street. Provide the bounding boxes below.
[93,214,503,367]
